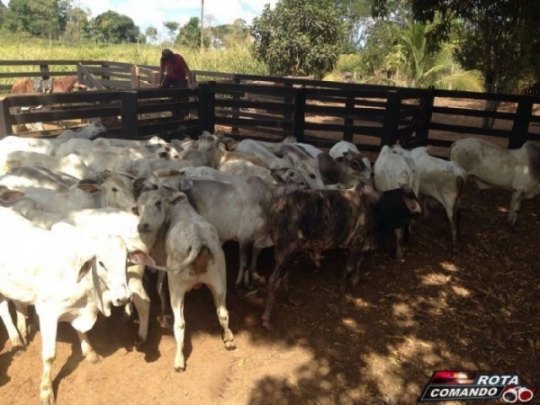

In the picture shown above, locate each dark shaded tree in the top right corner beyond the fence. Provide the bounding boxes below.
[374,0,540,92]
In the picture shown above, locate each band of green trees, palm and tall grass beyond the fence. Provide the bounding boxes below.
[0,0,540,93]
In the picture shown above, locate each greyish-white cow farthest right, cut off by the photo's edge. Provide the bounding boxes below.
[450,138,540,225]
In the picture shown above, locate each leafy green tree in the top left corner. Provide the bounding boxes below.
[3,0,70,38]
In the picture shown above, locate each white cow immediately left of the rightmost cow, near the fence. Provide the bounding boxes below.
[392,145,466,242]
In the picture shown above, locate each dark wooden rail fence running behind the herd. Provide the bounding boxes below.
[0,61,540,155]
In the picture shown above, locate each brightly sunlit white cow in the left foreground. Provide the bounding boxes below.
[0,207,144,404]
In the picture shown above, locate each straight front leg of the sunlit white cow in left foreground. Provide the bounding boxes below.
[36,308,58,405]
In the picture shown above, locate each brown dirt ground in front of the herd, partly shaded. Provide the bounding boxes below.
[0,98,540,405]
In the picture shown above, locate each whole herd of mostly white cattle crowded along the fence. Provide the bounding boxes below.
[0,121,540,403]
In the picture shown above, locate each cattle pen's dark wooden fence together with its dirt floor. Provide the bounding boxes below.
[0,61,540,405]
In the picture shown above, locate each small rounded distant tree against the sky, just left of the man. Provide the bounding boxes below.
[94,10,140,43]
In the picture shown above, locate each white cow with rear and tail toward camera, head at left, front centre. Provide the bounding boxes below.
[138,189,235,371]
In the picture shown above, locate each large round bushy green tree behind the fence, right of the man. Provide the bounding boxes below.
[251,0,343,78]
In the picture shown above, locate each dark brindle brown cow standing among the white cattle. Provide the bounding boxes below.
[263,183,421,329]
